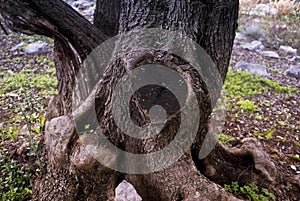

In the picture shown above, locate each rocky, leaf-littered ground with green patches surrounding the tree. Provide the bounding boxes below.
[0,1,300,200]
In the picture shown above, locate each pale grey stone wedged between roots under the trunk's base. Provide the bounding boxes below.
[115,180,142,201]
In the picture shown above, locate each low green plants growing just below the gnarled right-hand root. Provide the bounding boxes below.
[224,181,276,201]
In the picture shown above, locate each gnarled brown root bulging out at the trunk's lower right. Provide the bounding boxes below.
[194,138,277,187]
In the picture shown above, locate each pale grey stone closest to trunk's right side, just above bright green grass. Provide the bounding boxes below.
[234,61,271,79]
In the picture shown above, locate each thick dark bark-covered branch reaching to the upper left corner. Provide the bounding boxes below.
[0,0,106,58]
